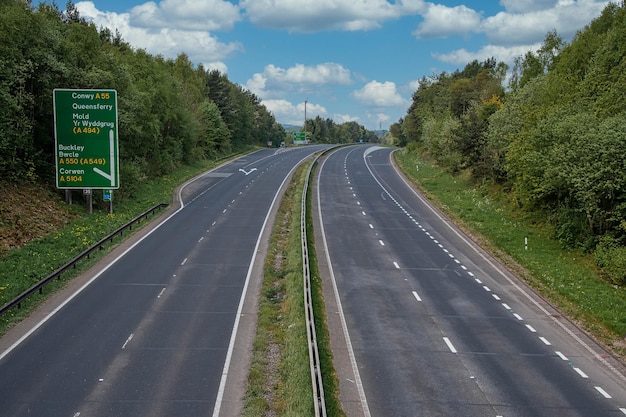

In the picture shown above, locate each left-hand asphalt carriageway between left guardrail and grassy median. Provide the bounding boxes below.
[0,147,320,417]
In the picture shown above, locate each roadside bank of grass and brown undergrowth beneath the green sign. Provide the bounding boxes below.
[0,154,223,333]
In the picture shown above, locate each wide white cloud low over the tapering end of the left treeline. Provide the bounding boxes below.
[246,62,352,98]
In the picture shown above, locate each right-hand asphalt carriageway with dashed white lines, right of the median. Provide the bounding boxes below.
[317,146,626,417]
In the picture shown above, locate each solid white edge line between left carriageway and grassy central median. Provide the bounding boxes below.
[213,148,311,417]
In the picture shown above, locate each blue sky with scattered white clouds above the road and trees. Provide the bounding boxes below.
[59,0,609,130]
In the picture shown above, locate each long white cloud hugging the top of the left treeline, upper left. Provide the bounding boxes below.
[76,1,243,62]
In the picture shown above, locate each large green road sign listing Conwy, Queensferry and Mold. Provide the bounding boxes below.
[54,88,120,189]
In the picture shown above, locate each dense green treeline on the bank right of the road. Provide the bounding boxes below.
[391,3,626,285]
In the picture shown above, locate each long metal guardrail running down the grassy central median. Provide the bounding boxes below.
[300,156,326,417]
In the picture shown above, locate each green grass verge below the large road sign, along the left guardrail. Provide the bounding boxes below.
[0,154,244,335]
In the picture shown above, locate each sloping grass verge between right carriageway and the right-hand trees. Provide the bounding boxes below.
[394,150,626,361]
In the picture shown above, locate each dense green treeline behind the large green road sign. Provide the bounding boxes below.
[0,0,285,196]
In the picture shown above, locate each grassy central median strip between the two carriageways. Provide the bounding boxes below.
[243,160,344,417]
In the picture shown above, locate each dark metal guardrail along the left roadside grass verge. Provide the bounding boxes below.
[0,203,167,316]
